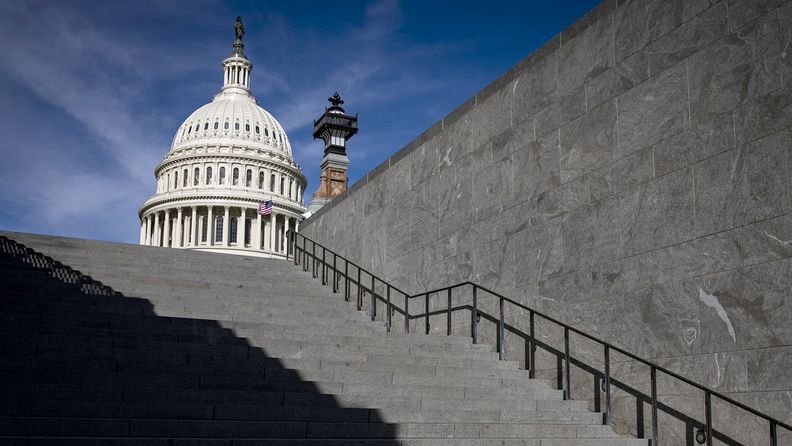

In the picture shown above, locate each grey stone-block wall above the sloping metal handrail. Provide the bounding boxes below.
[301,0,792,441]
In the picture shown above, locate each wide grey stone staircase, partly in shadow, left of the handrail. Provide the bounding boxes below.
[0,233,647,446]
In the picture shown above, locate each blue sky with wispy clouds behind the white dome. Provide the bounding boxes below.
[0,0,599,243]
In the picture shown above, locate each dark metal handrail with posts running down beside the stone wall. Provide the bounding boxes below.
[288,231,792,446]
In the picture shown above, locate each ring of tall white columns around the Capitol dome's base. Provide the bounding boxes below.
[140,205,300,255]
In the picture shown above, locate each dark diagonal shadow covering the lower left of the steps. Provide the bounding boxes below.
[0,237,398,445]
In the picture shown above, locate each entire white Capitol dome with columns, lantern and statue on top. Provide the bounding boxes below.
[138,21,307,257]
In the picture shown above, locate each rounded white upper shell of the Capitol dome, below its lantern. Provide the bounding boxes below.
[171,92,292,158]
